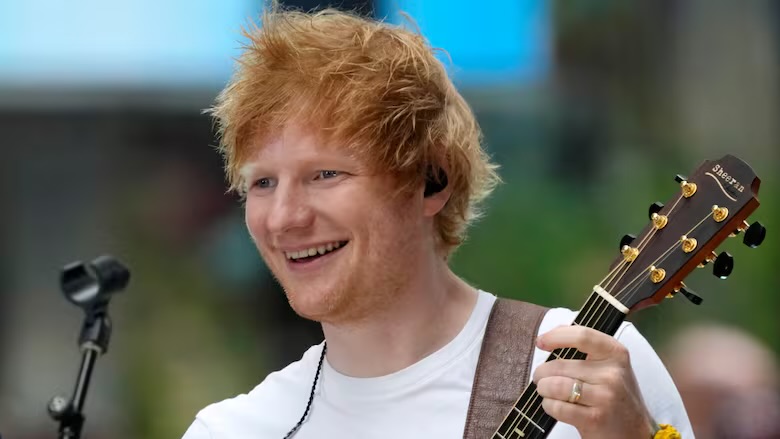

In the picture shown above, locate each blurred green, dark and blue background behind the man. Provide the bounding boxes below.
[0,0,780,439]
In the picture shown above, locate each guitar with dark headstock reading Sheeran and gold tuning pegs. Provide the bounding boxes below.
[492,155,766,439]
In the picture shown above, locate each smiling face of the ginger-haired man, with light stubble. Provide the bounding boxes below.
[244,125,435,323]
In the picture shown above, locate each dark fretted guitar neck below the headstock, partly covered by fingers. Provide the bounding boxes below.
[492,292,626,439]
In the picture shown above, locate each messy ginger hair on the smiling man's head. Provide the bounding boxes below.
[211,7,498,255]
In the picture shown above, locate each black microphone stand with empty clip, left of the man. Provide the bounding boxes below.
[47,256,130,439]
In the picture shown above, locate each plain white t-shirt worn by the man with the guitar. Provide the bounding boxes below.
[183,291,693,439]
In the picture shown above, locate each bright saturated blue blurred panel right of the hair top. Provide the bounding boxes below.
[377,0,551,85]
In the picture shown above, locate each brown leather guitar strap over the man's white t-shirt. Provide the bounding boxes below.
[463,298,547,439]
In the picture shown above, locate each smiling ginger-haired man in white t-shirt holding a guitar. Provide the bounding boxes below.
[184,8,693,439]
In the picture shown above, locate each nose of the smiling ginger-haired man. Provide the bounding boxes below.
[266,184,314,234]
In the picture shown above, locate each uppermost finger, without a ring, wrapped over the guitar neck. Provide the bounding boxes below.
[536,325,628,360]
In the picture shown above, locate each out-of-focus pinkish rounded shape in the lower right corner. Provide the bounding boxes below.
[659,324,780,439]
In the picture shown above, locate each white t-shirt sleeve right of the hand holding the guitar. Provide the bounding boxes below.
[615,323,694,439]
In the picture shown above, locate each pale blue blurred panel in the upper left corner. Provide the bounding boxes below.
[0,0,262,86]
